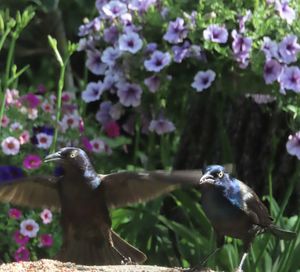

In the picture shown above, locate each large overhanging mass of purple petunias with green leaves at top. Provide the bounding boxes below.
[79,0,300,159]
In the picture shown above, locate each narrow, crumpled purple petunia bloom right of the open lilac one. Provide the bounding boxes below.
[231,29,252,68]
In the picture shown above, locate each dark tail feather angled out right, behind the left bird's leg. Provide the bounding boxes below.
[111,231,147,264]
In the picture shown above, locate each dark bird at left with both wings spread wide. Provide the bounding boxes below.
[0,147,201,265]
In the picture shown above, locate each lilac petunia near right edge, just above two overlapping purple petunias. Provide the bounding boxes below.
[278,34,300,64]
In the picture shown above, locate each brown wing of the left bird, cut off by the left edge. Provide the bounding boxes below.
[0,175,60,209]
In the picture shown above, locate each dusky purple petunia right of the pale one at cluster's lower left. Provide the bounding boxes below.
[117,83,143,107]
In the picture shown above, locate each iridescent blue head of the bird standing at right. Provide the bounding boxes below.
[200,165,229,186]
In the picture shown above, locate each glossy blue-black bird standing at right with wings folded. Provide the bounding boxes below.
[200,165,296,271]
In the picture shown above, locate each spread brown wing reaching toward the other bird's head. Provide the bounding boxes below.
[99,170,202,208]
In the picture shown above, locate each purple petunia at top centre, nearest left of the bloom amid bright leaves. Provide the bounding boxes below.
[163,18,188,43]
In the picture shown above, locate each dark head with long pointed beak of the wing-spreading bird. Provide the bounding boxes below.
[44,147,90,169]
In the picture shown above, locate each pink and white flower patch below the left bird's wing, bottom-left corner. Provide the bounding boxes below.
[1,207,58,261]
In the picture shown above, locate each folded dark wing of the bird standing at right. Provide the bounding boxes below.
[237,180,272,227]
